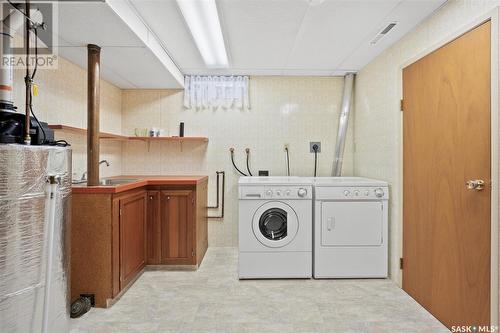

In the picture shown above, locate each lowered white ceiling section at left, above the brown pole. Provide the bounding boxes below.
[53,0,183,89]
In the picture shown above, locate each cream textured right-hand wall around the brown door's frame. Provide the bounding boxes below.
[354,0,499,282]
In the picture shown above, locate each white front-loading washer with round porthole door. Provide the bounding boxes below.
[238,177,312,279]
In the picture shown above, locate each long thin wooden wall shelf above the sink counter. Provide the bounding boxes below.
[49,125,208,142]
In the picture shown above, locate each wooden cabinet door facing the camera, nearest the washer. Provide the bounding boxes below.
[161,190,195,265]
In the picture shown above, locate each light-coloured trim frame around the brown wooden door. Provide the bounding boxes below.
[398,7,500,326]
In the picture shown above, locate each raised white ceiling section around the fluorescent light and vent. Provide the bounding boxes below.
[130,0,445,75]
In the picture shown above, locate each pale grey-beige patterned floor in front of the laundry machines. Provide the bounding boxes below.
[71,248,449,333]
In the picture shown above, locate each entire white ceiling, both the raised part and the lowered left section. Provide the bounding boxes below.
[51,0,445,89]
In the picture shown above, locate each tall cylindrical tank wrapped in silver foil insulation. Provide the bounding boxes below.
[0,145,71,333]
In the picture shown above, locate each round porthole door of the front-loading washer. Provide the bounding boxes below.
[253,201,299,248]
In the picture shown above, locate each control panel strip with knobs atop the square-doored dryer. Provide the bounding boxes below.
[316,186,389,200]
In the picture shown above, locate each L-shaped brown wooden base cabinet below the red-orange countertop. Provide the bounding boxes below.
[71,179,208,307]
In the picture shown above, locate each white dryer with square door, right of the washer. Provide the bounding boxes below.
[313,177,389,278]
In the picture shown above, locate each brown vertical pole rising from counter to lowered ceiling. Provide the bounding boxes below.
[87,44,101,186]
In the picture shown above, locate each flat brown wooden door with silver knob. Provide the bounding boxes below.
[403,22,491,328]
